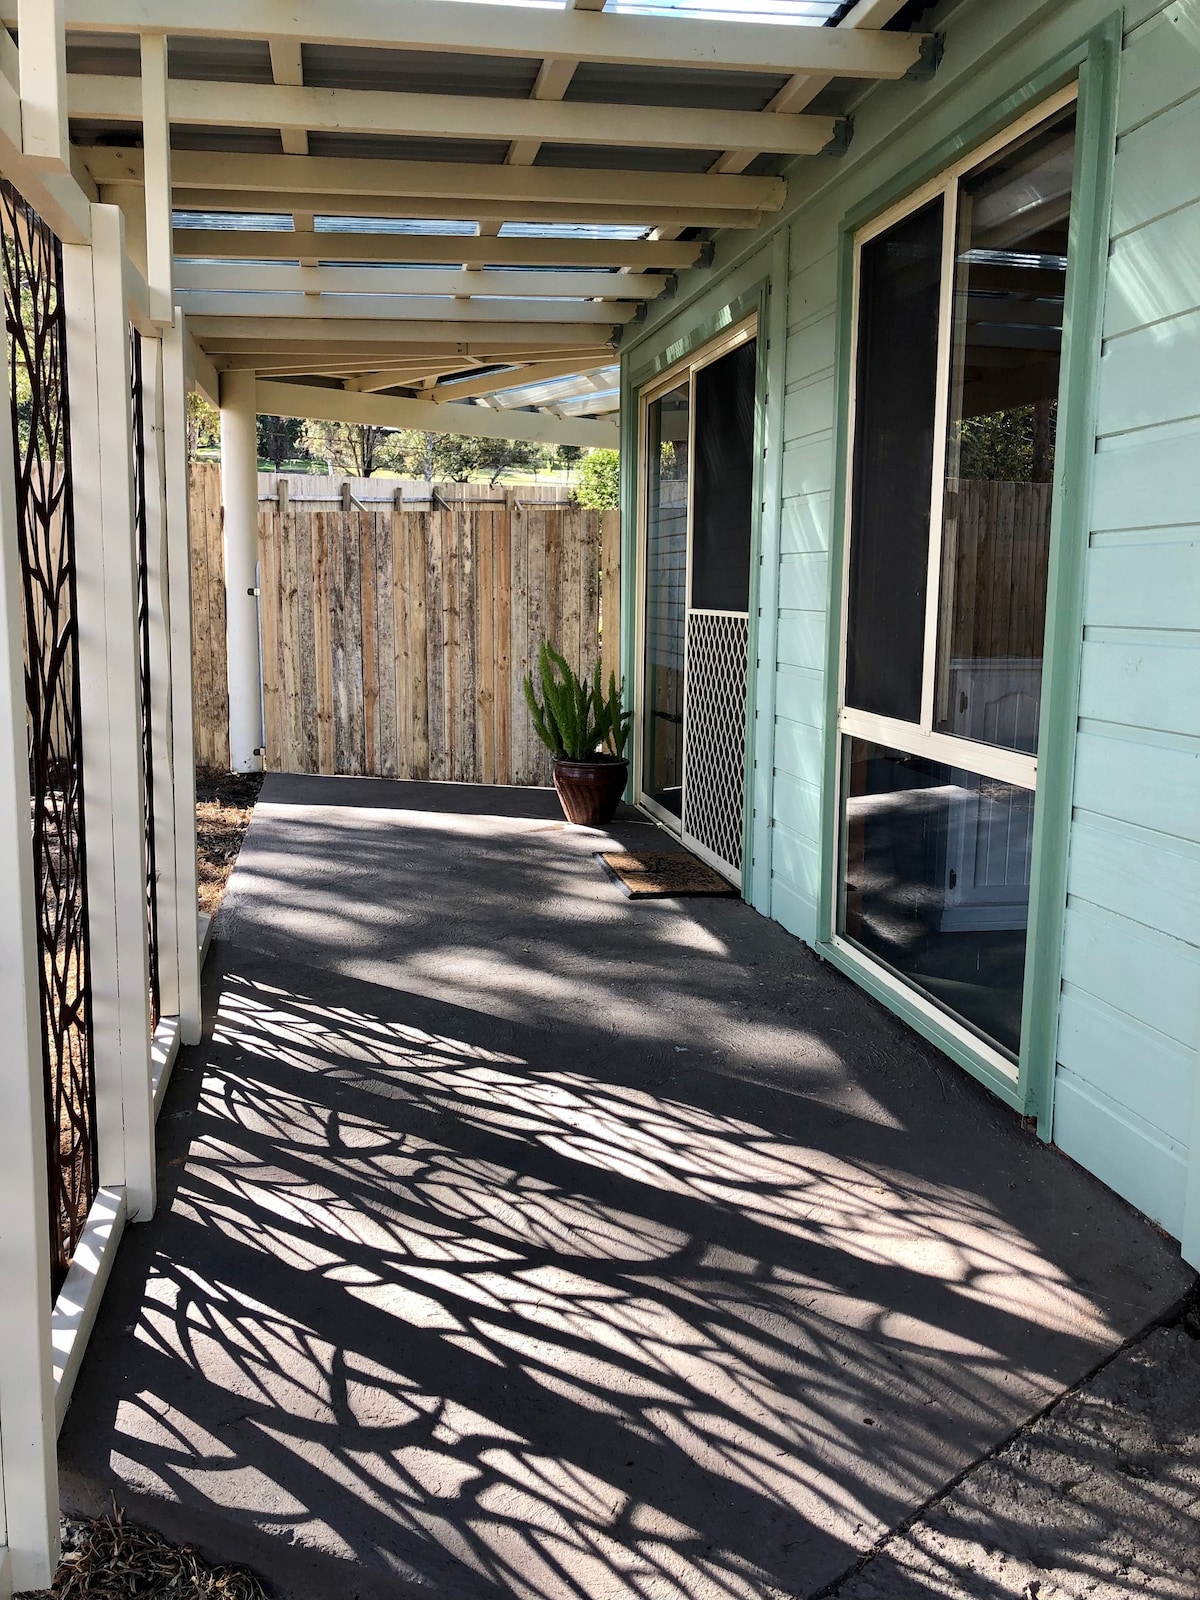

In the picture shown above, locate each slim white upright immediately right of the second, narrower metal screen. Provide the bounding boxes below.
[142,339,179,1016]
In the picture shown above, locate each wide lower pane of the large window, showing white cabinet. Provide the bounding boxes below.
[840,739,1034,1058]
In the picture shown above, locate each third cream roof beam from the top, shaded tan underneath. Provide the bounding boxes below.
[83,145,787,221]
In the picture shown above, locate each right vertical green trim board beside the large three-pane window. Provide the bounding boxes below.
[1021,13,1122,1139]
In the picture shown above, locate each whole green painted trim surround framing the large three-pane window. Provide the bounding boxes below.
[816,11,1122,1138]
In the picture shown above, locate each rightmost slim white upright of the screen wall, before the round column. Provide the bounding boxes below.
[162,312,203,1045]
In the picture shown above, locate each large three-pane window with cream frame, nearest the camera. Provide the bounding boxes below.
[834,94,1075,1078]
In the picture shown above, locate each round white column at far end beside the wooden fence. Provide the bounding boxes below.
[221,373,262,773]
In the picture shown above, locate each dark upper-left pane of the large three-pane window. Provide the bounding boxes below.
[846,198,944,722]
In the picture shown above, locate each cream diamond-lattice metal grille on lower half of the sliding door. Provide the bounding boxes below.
[683,611,750,875]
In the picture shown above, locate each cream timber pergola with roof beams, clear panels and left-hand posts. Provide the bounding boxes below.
[0,0,936,1592]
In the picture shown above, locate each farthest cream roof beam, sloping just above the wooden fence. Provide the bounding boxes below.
[254,372,618,446]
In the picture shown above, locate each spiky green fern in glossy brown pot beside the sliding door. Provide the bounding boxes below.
[525,643,632,827]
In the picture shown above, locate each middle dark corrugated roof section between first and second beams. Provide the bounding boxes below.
[301,45,541,99]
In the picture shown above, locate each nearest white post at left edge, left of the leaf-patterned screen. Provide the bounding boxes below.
[0,219,59,1589]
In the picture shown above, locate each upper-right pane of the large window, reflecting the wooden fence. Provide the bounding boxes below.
[934,110,1075,752]
